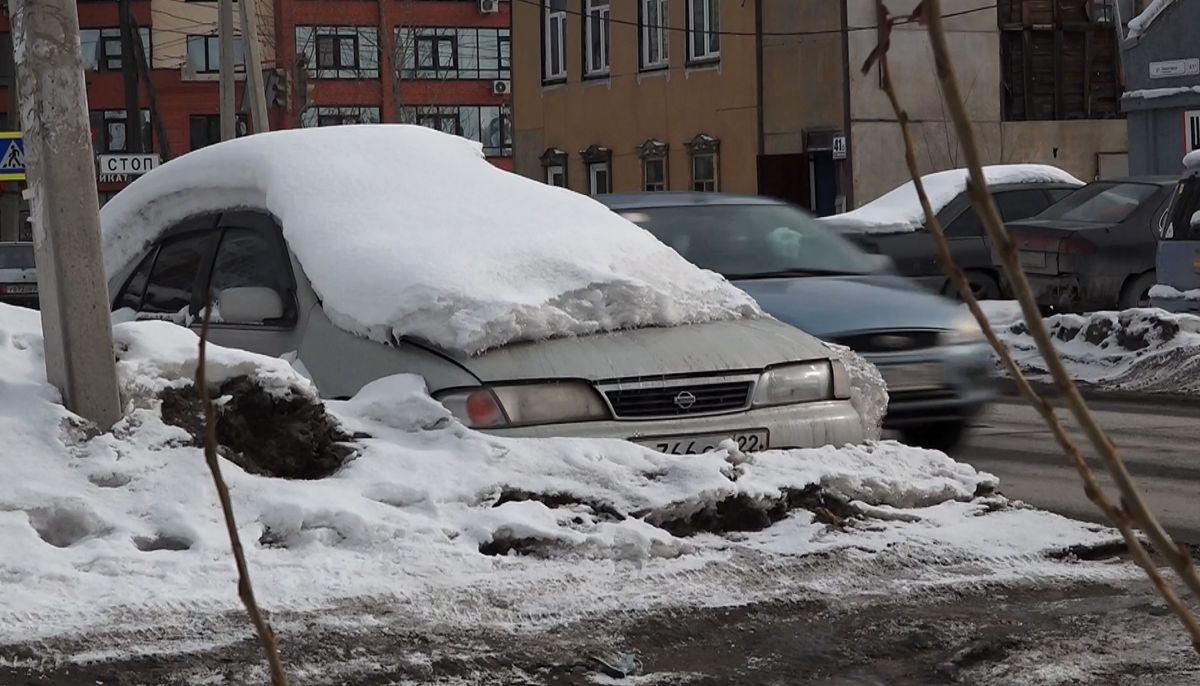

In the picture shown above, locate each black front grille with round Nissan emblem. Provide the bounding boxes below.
[605,381,754,419]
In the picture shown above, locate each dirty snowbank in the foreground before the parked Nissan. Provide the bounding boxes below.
[0,306,1135,651]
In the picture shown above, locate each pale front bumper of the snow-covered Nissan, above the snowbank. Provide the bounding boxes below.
[486,401,864,450]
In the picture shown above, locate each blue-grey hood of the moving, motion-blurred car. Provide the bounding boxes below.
[734,275,961,338]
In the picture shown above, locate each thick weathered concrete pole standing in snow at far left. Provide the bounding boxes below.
[8,0,121,431]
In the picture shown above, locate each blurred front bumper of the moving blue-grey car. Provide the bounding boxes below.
[864,343,996,428]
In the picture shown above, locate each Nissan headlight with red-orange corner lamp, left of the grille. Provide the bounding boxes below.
[438,381,610,428]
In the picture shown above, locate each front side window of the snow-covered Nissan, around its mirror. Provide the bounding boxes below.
[209,219,296,326]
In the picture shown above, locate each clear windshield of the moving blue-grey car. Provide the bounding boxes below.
[620,204,874,278]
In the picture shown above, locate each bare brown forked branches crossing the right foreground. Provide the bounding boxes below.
[863,0,1200,652]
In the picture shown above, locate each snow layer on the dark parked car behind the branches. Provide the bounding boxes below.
[821,164,1084,233]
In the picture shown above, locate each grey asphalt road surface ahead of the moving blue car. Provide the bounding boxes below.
[954,396,1200,544]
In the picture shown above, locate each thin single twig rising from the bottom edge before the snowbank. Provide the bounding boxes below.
[196,294,288,686]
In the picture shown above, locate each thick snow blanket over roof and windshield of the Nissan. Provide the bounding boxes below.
[101,125,760,354]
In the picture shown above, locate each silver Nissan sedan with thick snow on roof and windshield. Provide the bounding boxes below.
[101,126,864,453]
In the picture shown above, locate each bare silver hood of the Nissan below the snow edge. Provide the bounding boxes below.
[443,318,829,383]
